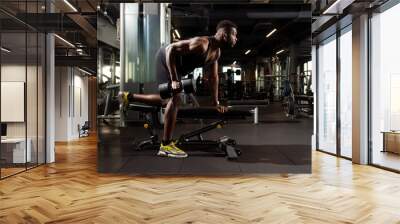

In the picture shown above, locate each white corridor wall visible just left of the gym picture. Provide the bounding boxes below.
[55,67,89,141]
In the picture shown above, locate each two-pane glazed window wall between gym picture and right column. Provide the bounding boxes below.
[317,24,352,159]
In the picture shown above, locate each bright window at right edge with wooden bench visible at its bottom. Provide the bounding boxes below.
[371,4,400,170]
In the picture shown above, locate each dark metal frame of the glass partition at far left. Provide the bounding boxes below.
[0,0,47,180]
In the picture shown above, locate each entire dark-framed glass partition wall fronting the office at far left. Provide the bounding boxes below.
[0,1,46,179]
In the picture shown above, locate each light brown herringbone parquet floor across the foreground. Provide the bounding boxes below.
[0,137,400,224]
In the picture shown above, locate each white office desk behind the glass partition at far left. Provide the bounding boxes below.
[1,138,32,163]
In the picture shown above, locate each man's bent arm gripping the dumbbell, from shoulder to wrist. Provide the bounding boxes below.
[165,37,207,81]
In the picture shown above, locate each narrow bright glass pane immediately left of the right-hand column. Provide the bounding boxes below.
[340,29,353,158]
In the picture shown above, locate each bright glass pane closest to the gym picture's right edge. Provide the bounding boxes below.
[318,36,336,154]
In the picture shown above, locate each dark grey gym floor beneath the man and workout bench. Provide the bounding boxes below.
[98,103,313,175]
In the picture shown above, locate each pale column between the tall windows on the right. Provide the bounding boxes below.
[352,15,368,164]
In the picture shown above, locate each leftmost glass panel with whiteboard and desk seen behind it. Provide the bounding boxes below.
[1,32,27,177]
